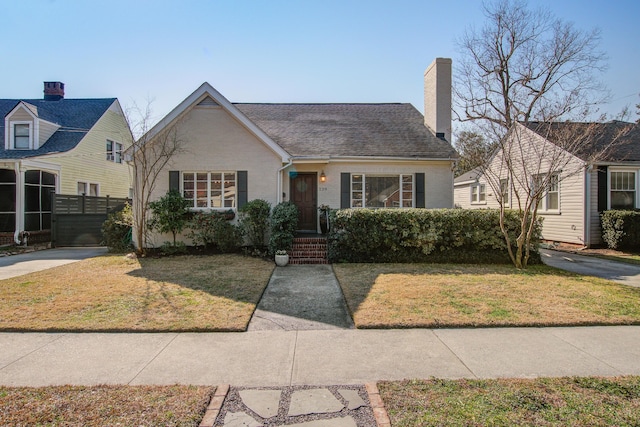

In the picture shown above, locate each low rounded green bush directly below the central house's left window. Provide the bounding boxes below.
[187,212,242,253]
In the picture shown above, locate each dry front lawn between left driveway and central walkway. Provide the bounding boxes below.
[0,255,274,331]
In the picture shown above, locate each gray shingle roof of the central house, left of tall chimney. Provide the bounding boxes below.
[233,103,458,159]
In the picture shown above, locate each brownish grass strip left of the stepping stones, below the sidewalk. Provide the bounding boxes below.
[0,385,215,427]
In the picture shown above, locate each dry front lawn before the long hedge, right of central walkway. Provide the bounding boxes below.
[334,264,640,328]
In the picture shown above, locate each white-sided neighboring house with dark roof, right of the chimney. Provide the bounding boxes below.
[454,121,640,247]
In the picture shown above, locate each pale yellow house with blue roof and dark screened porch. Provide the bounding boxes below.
[0,82,132,244]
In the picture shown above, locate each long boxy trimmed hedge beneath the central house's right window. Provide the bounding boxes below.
[327,209,541,264]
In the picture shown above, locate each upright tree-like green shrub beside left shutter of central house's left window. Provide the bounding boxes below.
[148,190,189,246]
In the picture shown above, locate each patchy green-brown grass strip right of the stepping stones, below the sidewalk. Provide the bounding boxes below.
[378,376,640,427]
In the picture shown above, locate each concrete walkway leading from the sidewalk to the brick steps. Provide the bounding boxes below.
[248,265,354,331]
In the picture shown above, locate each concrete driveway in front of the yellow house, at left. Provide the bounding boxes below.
[0,247,107,280]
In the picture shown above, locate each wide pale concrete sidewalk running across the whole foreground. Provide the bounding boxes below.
[0,326,640,386]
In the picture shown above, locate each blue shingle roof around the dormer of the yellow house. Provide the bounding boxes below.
[0,98,116,159]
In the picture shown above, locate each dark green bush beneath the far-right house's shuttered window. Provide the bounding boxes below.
[600,210,640,249]
